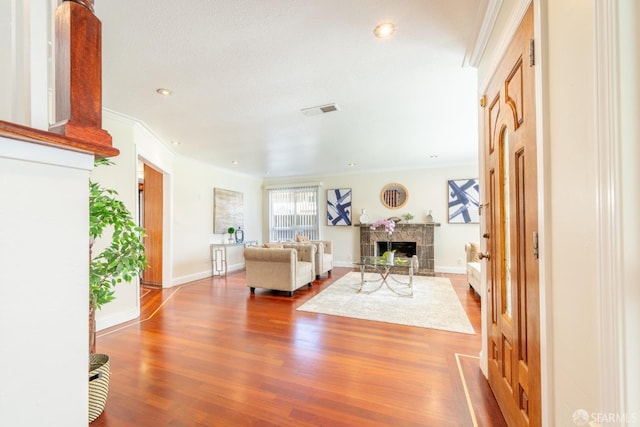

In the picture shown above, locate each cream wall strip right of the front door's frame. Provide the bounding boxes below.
[543,0,601,424]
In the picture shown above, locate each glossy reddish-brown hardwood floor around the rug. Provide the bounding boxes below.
[91,268,505,427]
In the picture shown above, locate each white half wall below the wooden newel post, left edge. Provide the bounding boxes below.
[0,138,93,427]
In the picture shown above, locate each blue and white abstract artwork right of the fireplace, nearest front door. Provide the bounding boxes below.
[449,178,480,224]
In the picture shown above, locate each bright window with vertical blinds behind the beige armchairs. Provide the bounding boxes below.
[269,185,320,242]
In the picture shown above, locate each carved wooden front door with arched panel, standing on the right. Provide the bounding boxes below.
[483,6,541,426]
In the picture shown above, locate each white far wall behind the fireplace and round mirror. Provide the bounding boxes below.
[262,165,479,273]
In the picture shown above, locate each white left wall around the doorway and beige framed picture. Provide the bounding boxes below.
[100,111,262,290]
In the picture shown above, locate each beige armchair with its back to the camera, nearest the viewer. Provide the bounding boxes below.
[244,245,316,296]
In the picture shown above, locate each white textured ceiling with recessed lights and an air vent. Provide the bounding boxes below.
[96,0,486,178]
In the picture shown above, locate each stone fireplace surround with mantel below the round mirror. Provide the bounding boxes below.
[359,223,440,276]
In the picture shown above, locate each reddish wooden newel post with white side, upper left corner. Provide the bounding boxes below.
[49,0,112,147]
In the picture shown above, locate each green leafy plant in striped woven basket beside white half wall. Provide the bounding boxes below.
[89,158,147,422]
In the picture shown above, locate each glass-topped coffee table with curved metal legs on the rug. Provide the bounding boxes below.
[353,255,418,298]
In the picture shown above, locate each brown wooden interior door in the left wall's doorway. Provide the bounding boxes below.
[142,163,163,286]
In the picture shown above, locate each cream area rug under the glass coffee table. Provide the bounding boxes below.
[298,272,475,334]
